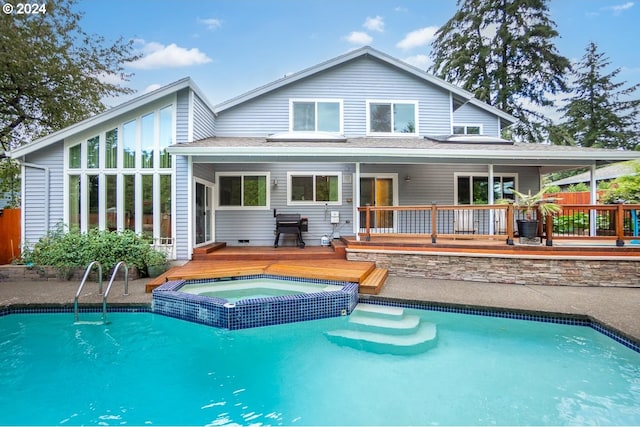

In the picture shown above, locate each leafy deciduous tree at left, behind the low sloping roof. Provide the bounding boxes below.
[0,0,136,150]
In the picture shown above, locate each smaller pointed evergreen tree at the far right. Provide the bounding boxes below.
[552,42,640,150]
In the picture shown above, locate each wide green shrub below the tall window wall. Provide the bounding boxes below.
[23,225,166,280]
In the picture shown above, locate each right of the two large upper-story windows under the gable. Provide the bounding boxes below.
[367,101,418,136]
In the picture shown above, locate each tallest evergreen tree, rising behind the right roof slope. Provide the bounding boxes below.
[431,0,570,142]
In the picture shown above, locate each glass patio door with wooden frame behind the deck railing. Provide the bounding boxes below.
[360,176,396,232]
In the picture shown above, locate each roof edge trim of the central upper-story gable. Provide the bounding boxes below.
[214,46,517,124]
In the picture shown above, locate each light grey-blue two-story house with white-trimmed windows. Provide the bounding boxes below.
[10,47,638,259]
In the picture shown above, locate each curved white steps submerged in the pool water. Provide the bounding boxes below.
[326,303,437,355]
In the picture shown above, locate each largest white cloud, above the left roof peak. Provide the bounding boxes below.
[130,42,212,70]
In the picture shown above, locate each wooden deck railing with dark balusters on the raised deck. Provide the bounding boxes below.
[358,204,640,246]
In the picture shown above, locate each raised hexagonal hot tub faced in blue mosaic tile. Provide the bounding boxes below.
[153,274,358,329]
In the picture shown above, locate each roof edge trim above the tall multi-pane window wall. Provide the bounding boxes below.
[7,77,213,159]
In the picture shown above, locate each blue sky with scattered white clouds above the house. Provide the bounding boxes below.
[76,0,640,110]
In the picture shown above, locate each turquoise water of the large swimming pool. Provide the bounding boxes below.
[0,309,640,425]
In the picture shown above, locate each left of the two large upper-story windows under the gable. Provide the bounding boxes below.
[290,99,342,133]
